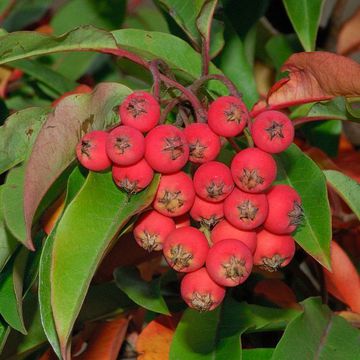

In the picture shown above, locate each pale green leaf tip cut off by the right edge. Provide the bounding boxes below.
[324,170,360,219]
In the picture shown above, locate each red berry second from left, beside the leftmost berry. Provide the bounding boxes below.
[106,126,145,166]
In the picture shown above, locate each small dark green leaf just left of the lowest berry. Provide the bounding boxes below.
[114,267,170,315]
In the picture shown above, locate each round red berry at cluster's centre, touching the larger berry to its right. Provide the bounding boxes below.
[193,161,234,202]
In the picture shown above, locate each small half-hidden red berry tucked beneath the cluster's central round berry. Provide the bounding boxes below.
[190,196,224,227]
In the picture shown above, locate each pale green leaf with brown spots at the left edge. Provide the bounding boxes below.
[0,107,49,173]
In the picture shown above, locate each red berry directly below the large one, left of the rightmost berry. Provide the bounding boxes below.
[224,188,268,230]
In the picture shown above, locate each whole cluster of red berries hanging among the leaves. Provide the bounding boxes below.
[77,92,302,311]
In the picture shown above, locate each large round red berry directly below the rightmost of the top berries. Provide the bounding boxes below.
[231,148,277,193]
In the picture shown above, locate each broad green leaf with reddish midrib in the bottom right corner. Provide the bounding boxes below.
[271,298,360,360]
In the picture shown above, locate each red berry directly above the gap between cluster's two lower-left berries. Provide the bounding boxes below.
[153,171,195,217]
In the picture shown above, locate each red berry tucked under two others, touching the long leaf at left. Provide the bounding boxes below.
[112,159,154,194]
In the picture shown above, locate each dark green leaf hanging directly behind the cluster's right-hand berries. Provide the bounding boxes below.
[275,144,332,269]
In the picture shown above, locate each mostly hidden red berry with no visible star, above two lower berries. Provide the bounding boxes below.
[211,220,256,254]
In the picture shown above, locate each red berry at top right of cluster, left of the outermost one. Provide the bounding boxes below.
[208,96,249,137]
